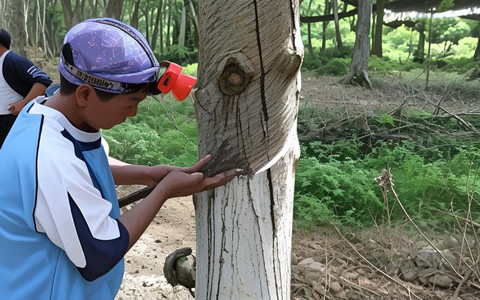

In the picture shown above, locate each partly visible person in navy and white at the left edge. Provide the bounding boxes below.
[0,28,52,148]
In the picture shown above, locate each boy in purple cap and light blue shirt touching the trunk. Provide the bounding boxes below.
[0,18,235,300]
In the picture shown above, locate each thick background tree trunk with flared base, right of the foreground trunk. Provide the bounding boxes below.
[342,0,372,88]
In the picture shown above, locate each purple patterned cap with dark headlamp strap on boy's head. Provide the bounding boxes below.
[58,18,159,93]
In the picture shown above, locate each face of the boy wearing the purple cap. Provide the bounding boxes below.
[85,91,148,130]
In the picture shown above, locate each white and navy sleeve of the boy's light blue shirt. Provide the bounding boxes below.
[34,122,129,280]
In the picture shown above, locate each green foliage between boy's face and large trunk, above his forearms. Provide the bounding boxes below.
[103,96,197,166]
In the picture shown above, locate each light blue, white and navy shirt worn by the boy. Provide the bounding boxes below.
[0,97,129,300]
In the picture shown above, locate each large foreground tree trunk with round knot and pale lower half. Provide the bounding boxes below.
[193,0,303,299]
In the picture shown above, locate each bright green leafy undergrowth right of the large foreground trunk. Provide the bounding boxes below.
[294,141,480,226]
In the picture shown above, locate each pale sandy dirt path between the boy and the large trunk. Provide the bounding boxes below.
[116,187,195,300]
